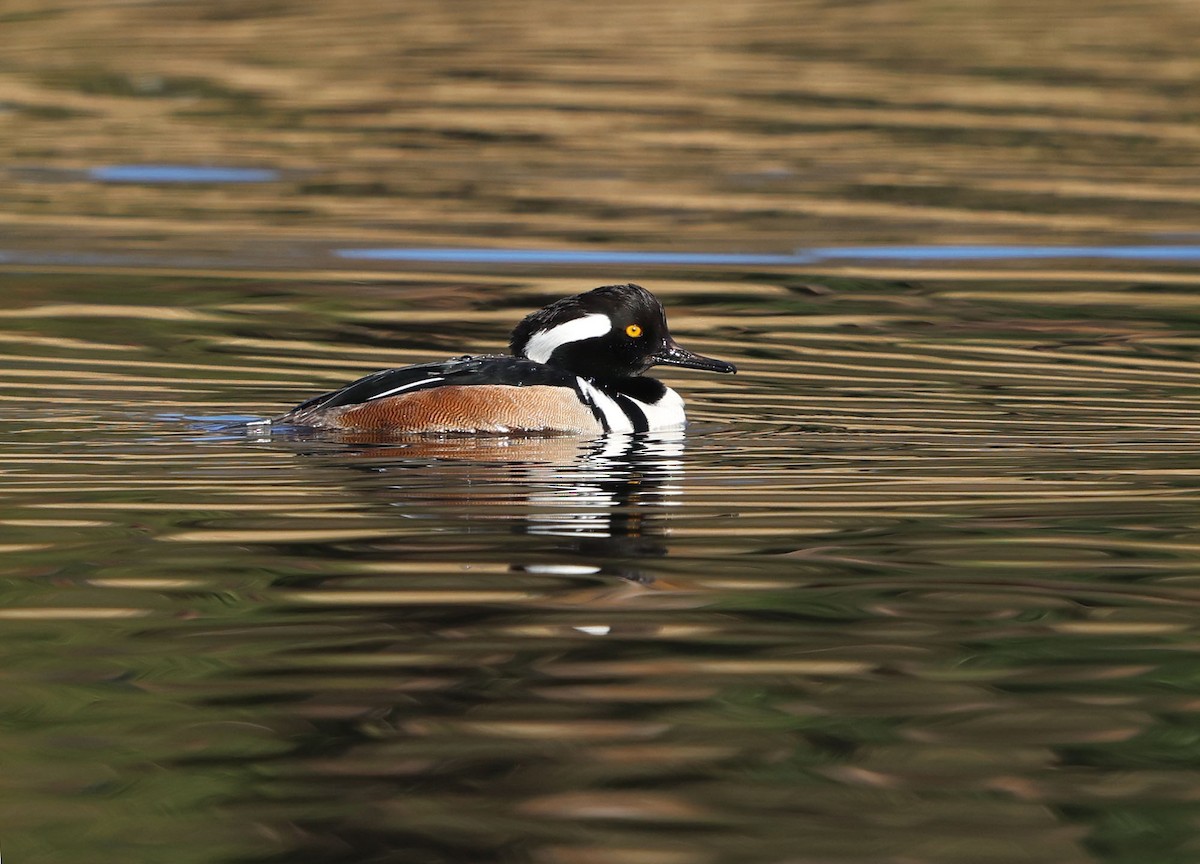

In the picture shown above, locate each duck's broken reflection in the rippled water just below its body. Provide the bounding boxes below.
[272,431,685,584]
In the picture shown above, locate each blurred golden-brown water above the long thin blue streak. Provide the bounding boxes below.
[9,0,1200,265]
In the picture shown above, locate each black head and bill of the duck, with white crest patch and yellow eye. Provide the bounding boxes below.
[509,282,737,379]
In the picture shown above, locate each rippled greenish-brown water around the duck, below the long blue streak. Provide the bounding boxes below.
[0,268,1200,862]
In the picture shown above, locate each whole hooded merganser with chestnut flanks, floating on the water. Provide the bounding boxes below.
[275,283,737,434]
